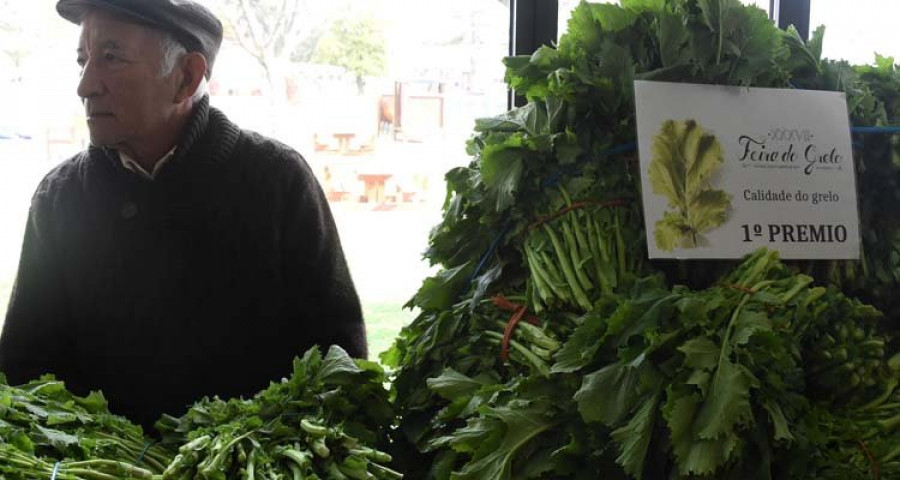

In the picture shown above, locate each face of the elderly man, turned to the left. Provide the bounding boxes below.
[78,11,176,149]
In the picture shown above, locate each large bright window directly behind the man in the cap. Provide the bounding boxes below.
[0,0,509,357]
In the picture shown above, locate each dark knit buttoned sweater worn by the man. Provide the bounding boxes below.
[0,100,366,426]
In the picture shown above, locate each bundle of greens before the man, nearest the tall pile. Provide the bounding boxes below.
[156,346,402,480]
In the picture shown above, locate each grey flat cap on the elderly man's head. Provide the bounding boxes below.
[56,0,222,78]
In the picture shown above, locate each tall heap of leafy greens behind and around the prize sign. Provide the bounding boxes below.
[382,0,900,480]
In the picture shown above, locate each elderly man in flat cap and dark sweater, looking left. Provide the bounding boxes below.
[0,0,366,426]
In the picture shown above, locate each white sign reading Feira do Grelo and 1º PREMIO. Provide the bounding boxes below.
[635,81,860,259]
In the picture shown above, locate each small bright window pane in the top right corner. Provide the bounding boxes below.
[809,0,900,64]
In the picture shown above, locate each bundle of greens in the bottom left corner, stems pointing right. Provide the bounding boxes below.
[0,375,173,480]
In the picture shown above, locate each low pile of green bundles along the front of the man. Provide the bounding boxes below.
[0,346,402,480]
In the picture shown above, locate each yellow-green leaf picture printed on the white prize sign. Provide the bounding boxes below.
[650,120,731,251]
